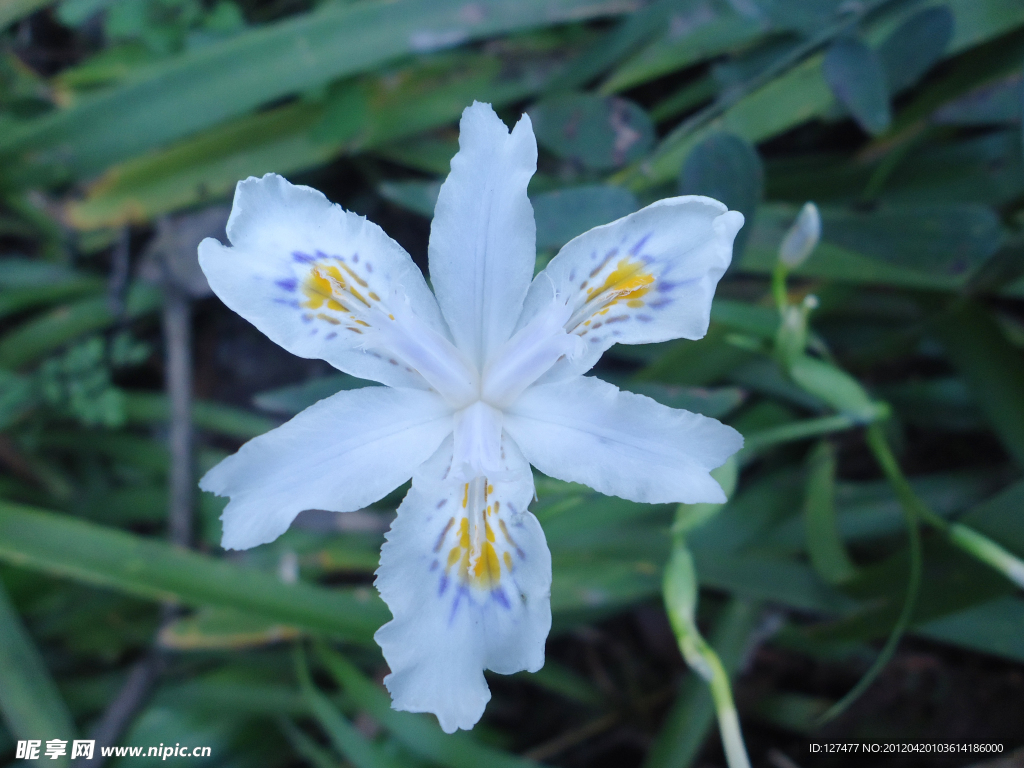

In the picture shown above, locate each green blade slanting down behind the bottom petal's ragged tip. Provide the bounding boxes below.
[316,644,538,768]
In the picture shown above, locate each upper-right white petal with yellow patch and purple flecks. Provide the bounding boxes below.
[518,197,743,381]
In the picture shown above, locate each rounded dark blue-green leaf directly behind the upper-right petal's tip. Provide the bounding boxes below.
[679,133,765,259]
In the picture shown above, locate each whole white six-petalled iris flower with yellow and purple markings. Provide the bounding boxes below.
[199,103,743,733]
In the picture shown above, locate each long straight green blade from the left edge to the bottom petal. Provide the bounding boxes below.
[0,503,387,644]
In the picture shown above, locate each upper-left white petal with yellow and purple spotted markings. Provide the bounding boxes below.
[199,173,447,388]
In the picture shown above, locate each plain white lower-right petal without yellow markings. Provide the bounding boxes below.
[504,376,743,504]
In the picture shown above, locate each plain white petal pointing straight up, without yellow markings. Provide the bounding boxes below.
[429,102,537,369]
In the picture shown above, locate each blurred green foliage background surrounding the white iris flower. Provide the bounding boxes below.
[0,0,1024,768]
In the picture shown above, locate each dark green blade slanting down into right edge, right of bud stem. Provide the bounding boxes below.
[935,302,1024,465]
